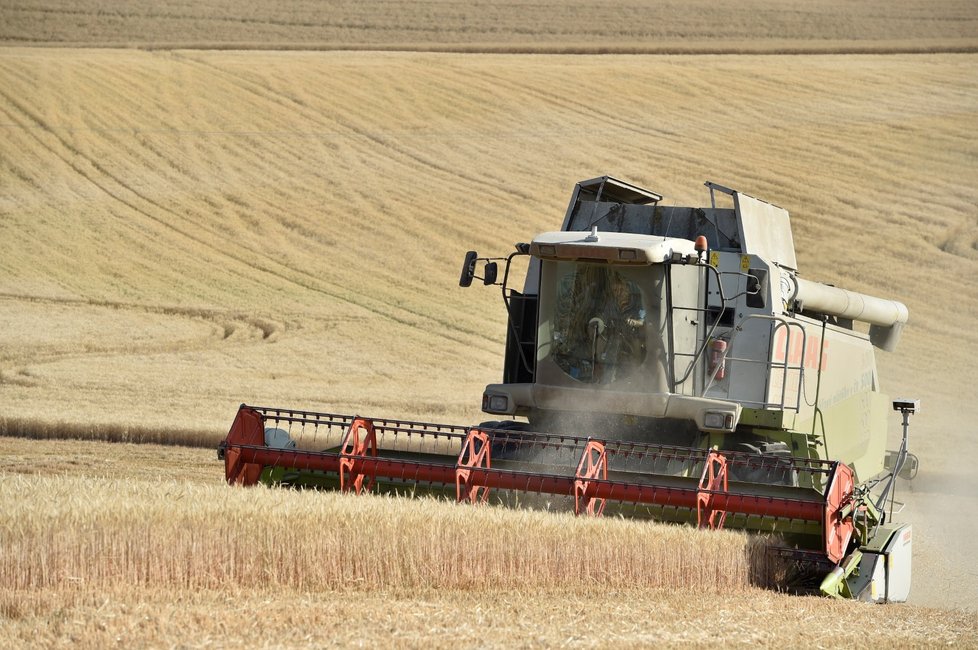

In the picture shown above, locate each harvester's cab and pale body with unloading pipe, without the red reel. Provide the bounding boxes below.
[463,177,907,466]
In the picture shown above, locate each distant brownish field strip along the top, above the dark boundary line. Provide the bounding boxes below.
[0,0,978,56]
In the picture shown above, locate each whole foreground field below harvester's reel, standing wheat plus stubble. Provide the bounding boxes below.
[0,438,978,648]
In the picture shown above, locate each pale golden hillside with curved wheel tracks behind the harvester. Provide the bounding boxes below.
[0,49,978,426]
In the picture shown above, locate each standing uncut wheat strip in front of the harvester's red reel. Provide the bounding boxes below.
[0,475,763,593]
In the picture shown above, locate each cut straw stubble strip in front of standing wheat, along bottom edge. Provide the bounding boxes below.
[0,589,978,648]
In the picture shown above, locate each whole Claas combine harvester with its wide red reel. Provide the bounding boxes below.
[218,176,918,602]
